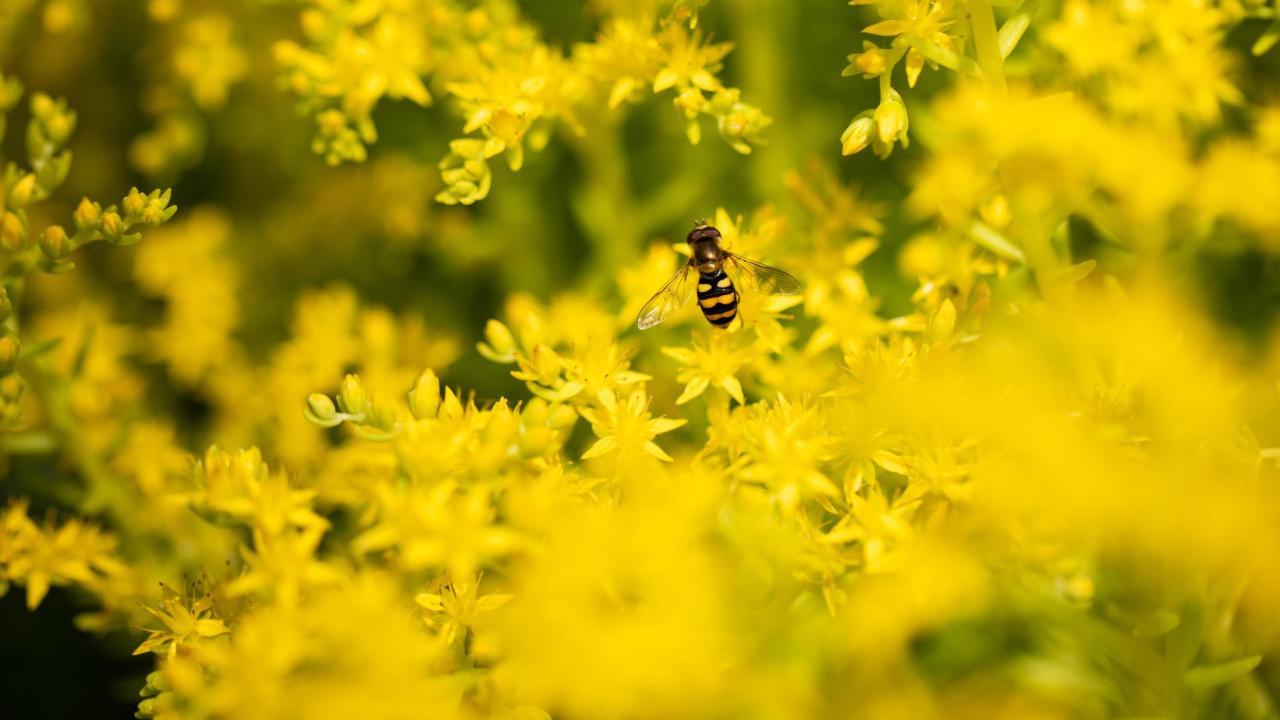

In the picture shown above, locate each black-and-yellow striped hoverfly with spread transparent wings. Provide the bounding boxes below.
[636,222,800,331]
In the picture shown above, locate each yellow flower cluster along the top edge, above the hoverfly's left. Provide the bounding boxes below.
[275,0,771,205]
